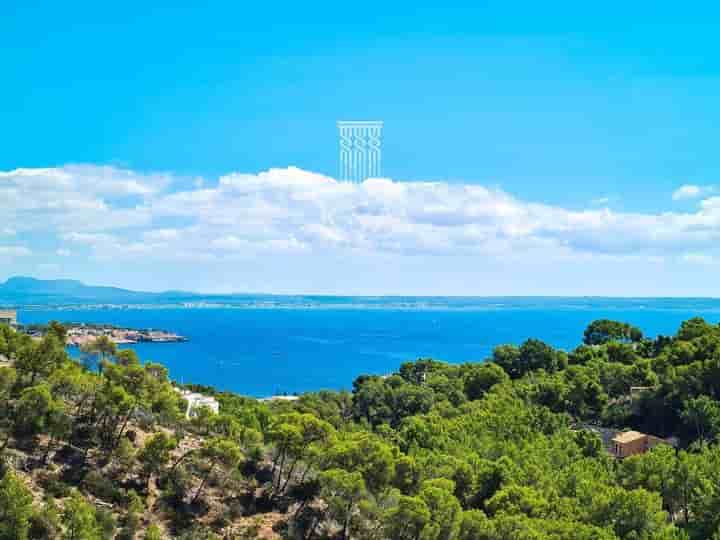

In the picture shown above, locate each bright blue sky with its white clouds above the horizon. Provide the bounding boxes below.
[0,1,720,296]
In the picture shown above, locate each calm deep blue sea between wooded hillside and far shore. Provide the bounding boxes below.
[19,298,720,397]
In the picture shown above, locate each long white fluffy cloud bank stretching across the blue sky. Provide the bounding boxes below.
[7,166,720,262]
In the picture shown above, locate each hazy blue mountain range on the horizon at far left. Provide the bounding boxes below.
[0,277,204,306]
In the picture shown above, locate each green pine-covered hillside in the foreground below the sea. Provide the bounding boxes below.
[0,319,720,540]
